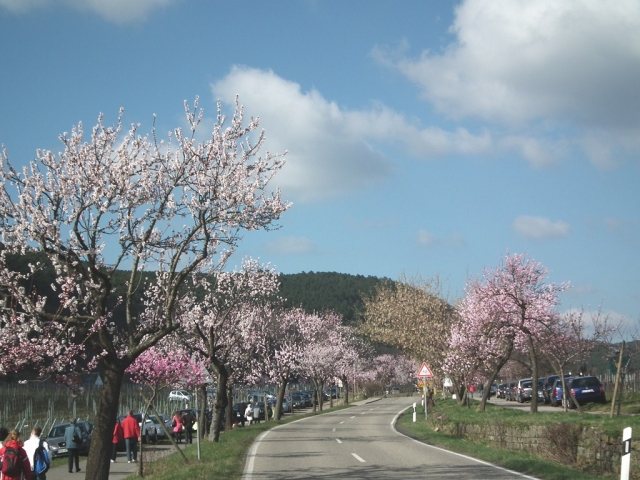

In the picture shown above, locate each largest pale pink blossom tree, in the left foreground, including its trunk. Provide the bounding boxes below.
[0,95,289,480]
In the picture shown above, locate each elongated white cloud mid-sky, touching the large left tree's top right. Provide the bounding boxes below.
[212,66,491,201]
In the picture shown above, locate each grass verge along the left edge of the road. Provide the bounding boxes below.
[125,405,350,480]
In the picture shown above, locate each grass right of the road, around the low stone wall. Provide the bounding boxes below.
[397,400,640,480]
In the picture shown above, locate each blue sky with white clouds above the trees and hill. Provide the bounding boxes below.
[0,0,640,334]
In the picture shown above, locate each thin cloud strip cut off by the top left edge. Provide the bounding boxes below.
[0,0,182,23]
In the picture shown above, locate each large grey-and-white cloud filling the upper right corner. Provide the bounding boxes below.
[373,0,640,166]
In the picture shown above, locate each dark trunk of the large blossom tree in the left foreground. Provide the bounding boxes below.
[85,364,124,480]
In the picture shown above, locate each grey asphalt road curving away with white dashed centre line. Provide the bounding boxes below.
[243,397,533,480]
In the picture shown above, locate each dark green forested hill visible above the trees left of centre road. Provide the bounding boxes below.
[280,272,389,325]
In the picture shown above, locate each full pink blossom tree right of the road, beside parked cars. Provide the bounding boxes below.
[449,254,568,413]
